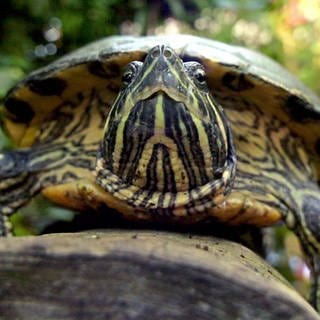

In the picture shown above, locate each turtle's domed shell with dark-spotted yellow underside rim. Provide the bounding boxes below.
[5,35,320,157]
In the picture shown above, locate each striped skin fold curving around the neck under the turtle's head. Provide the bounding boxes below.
[95,158,235,223]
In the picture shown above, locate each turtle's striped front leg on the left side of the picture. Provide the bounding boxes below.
[0,141,98,236]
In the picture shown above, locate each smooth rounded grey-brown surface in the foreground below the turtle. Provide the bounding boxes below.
[0,230,320,320]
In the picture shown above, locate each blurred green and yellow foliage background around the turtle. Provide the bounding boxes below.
[0,0,320,298]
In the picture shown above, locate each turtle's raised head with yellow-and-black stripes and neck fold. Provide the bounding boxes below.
[96,45,236,218]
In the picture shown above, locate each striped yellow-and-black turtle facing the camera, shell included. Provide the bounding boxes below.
[0,34,320,309]
